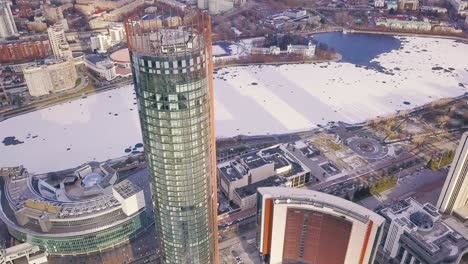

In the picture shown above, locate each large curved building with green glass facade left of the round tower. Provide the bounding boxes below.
[0,162,147,256]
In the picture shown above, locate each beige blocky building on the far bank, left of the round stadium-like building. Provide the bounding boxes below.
[23,60,78,96]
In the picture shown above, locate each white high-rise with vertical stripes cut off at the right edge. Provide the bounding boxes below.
[437,132,468,220]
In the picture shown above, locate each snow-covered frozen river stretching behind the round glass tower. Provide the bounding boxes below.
[0,34,468,173]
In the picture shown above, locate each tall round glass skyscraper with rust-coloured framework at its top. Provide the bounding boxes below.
[125,13,218,264]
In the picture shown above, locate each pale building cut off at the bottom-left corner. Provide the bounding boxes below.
[0,243,47,264]
